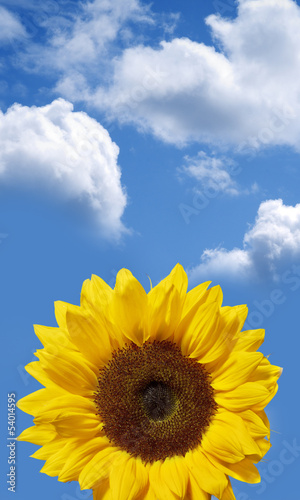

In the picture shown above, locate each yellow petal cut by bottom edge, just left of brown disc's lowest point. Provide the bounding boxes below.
[110,453,148,500]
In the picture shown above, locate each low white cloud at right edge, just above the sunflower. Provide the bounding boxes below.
[189,199,300,281]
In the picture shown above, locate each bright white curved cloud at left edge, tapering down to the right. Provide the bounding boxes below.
[0,99,126,238]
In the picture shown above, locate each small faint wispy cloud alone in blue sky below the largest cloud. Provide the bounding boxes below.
[179,151,239,195]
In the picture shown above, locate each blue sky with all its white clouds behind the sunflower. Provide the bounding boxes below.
[0,0,300,500]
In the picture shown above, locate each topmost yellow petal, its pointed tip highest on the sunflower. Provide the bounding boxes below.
[148,264,188,341]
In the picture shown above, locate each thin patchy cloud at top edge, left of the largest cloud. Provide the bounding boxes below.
[19,0,152,82]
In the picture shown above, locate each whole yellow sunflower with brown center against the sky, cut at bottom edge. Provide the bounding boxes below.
[18,264,281,500]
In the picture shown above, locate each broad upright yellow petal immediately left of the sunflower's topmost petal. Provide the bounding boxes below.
[111,269,147,345]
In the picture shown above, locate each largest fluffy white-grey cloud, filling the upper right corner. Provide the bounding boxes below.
[91,0,300,151]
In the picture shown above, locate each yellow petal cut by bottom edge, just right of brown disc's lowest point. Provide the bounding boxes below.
[149,456,189,500]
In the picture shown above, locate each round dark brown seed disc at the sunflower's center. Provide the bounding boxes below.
[95,341,217,463]
